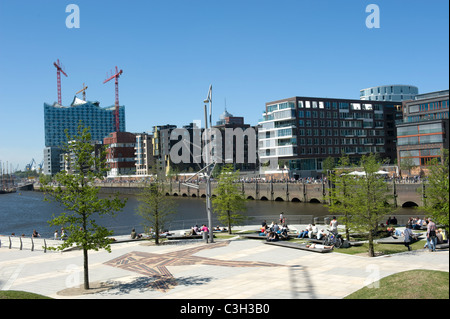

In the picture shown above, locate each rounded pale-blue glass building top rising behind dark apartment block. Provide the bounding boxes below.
[360,84,419,102]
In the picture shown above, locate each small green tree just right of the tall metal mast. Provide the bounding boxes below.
[212,165,247,234]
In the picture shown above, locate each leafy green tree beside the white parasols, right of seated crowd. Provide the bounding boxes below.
[346,154,393,257]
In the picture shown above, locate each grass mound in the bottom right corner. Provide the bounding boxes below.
[344,270,449,299]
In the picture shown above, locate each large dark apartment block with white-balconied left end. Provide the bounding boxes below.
[258,97,401,177]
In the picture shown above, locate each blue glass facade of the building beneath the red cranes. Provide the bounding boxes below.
[44,100,125,147]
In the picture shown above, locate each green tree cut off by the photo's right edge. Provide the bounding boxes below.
[424,149,449,230]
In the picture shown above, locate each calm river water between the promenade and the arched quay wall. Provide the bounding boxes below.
[0,191,417,238]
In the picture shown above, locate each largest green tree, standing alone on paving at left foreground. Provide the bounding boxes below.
[44,125,126,289]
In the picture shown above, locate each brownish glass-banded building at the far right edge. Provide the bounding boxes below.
[397,90,449,167]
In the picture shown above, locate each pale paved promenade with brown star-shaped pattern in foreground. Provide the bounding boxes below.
[0,225,449,301]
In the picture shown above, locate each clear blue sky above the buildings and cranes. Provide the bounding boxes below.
[0,0,449,169]
